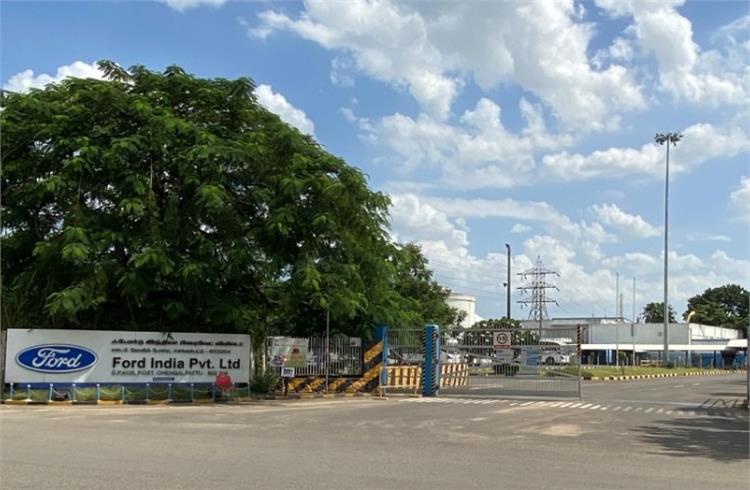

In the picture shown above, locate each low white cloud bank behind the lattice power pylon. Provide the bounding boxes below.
[391,194,750,317]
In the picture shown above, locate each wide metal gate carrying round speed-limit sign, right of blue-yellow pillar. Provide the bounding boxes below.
[440,326,585,398]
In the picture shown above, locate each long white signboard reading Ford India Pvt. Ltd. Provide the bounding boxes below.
[5,329,250,383]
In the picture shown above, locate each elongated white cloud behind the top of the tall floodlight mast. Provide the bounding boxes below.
[542,124,750,180]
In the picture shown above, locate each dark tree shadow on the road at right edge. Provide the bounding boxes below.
[635,411,750,463]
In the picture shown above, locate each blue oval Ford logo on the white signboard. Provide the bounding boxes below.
[16,344,96,373]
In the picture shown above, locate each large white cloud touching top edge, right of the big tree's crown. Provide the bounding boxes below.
[249,0,645,130]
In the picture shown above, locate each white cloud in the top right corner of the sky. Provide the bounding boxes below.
[596,0,750,106]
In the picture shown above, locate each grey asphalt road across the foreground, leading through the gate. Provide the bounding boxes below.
[0,376,750,490]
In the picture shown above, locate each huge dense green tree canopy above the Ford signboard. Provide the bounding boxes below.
[0,62,462,334]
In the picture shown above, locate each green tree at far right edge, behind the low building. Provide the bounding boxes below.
[683,284,750,329]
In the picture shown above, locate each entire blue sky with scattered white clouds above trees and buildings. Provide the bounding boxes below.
[0,0,750,317]
